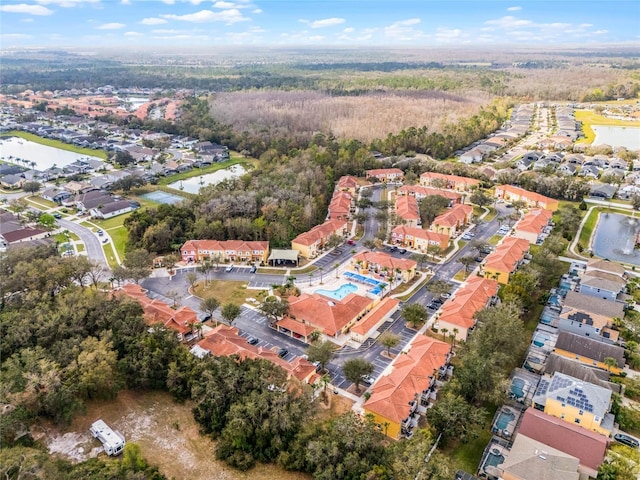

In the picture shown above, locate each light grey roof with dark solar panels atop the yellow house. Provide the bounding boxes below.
[533,372,611,418]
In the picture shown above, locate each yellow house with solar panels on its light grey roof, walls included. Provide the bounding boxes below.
[533,372,614,436]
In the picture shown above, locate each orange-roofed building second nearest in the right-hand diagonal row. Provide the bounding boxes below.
[437,275,499,341]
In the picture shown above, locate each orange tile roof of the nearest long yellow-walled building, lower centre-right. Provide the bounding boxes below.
[363,335,451,423]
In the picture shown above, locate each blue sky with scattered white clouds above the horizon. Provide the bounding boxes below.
[0,0,640,49]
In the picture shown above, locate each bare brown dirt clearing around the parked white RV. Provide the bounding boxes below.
[33,391,311,480]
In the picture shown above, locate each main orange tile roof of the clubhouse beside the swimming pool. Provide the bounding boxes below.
[289,293,372,336]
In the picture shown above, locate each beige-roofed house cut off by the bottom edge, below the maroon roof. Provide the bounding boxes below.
[500,433,580,480]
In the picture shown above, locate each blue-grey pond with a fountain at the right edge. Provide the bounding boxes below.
[591,213,640,265]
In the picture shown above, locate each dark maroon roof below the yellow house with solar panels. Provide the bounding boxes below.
[518,407,607,470]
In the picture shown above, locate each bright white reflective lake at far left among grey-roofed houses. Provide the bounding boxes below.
[0,137,104,171]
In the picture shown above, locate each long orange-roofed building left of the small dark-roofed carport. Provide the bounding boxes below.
[180,240,269,263]
